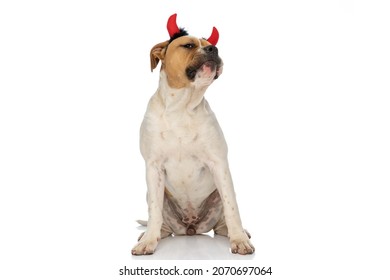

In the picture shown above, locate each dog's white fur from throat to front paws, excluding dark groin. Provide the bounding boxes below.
[132,54,254,255]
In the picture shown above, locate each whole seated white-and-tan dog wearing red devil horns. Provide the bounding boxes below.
[132,14,255,255]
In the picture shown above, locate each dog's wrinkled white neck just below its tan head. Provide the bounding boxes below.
[157,71,209,113]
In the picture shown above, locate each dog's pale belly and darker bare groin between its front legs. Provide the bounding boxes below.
[163,156,223,235]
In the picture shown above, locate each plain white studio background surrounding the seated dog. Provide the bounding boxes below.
[0,0,390,279]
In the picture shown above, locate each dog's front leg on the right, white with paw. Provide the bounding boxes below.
[210,160,255,255]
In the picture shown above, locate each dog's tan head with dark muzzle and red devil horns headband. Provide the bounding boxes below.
[150,14,223,88]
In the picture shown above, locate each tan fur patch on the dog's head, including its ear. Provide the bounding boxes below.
[150,36,218,88]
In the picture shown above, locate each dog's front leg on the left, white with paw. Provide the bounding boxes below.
[131,162,165,255]
